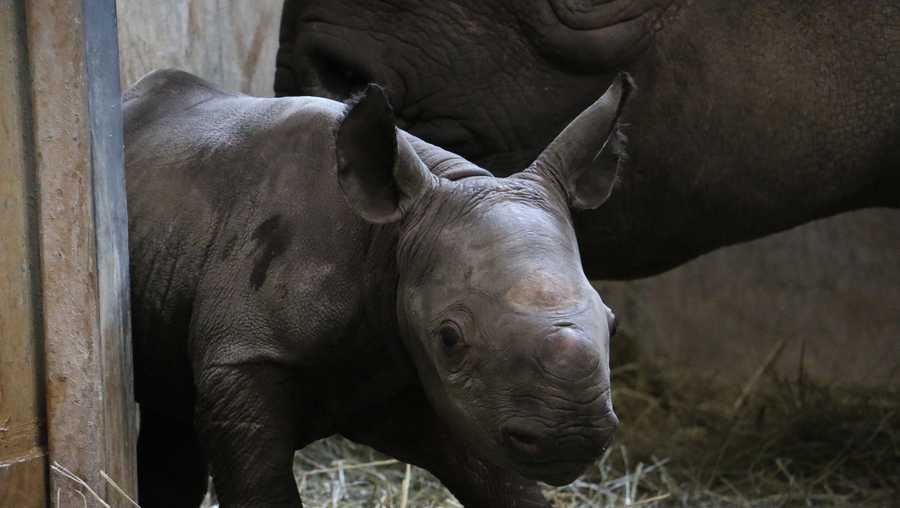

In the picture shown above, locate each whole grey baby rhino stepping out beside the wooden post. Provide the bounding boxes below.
[125,71,630,508]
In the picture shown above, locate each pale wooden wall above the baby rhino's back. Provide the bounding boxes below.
[117,0,282,96]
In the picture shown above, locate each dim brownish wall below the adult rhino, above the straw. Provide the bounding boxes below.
[598,209,900,390]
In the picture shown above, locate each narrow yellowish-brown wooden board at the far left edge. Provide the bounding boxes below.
[0,0,47,507]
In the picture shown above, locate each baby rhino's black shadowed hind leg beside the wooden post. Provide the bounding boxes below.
[138,405,207,508]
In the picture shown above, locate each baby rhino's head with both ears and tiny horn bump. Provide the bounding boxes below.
[336,73,631,484]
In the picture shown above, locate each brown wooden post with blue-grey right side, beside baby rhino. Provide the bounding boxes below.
[26,0,136,500]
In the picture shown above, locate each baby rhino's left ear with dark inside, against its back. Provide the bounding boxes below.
[335,84,431,224]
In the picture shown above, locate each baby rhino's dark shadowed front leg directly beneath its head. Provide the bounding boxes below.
[341,388,550,508]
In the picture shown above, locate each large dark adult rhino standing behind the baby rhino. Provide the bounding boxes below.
[275,0,900,278]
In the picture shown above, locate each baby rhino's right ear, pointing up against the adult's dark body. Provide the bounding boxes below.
[526,74,634,210]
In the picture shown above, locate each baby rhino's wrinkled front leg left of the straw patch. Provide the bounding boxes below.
[196,364,301,508]
